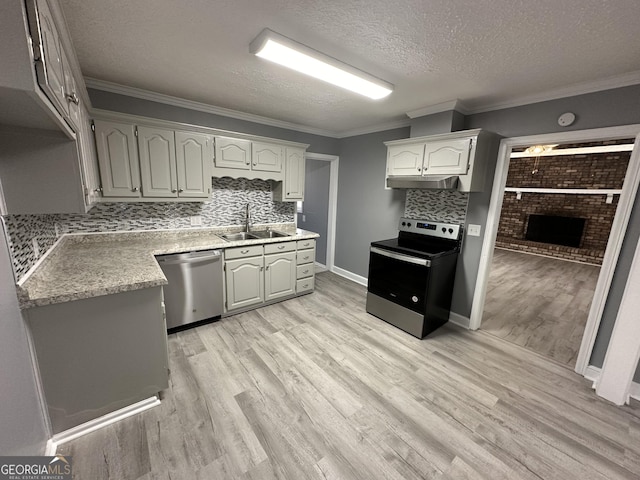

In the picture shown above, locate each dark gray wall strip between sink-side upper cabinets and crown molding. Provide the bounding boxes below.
[89,89,339,155]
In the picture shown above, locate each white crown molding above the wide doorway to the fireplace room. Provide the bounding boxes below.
[461,70,640,115]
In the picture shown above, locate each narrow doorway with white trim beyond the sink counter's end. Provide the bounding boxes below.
[296,153,339,271]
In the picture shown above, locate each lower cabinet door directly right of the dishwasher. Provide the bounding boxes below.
[225,256,264,310]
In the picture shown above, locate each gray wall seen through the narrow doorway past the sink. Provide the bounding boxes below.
[298,159,331,265]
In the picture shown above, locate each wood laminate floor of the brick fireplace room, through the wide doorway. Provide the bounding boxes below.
[480,248,600,367]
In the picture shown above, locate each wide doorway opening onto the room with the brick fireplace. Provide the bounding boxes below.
[481,138,634,367]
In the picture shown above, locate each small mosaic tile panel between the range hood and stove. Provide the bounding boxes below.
[404,189,469,224]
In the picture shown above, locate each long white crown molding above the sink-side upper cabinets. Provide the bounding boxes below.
[84,77,340,138]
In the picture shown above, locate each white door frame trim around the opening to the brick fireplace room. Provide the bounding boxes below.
[469,124,640,375]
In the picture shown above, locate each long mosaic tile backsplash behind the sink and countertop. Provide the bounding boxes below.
[3,178,295,280]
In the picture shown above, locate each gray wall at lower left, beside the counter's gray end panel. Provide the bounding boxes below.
[0,223,49,455]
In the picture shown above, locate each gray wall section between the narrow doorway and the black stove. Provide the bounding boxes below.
[335,127,409,277]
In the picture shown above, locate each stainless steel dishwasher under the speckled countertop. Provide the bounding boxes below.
[156,250,223,331]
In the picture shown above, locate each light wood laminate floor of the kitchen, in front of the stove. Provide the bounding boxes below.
[59,273,640,480]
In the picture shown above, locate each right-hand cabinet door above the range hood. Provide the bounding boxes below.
[424,138,472,175]
